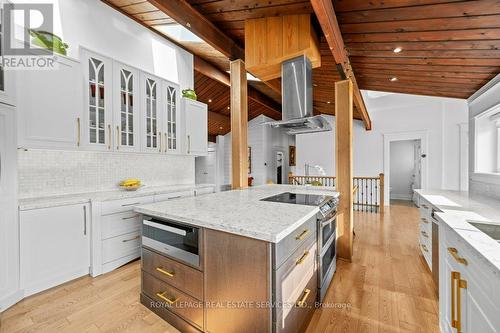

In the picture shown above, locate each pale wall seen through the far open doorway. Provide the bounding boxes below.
[390,140,415,200]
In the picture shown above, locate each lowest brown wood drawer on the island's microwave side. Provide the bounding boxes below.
[142,271,204,329]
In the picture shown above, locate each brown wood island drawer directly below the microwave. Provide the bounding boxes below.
[142,248,203,300]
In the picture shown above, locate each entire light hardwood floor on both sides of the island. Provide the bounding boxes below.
[0,204,439,333]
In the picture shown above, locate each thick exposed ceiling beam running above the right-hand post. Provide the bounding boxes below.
[311,0,372,130]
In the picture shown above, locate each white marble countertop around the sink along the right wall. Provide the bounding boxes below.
[415,190,500,271]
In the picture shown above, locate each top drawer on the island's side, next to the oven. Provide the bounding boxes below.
[275,216,317,267]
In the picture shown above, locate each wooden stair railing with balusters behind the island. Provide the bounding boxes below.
[288,173,385,213]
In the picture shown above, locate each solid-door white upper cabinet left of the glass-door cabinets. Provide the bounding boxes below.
[16,56,83,149]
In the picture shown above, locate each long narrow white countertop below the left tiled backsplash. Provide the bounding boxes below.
[19,184,215,210]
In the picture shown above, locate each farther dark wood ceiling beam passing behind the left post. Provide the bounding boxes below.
[194,56,281,119]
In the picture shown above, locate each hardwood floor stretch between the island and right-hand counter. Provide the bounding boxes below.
[307,202,439,333]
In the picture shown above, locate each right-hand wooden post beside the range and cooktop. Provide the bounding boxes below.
[335,80,354,261]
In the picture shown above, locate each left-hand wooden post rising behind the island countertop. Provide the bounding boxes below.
[230,59,248,190]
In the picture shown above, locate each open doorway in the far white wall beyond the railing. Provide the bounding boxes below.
[389,139,422,201]
